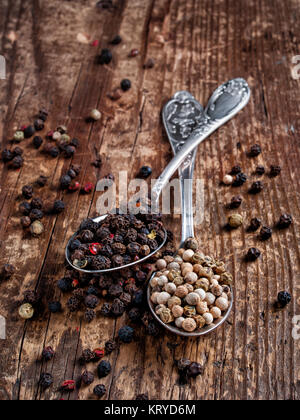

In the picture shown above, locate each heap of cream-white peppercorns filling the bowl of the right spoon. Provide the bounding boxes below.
[150,238,232,332]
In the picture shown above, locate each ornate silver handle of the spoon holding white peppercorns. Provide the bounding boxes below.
[162,91,203,242]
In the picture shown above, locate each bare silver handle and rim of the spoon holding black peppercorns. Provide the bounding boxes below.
[65,79,250,274]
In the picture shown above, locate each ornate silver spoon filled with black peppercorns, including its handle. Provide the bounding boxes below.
[66,79,250,273]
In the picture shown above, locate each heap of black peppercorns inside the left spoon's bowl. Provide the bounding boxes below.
[68,214,175,271]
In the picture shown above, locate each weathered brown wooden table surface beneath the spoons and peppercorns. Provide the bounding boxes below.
[0,0,300,400]
